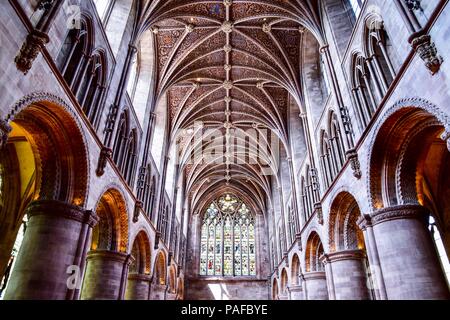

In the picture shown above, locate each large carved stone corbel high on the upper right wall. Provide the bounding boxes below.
[410,33,444,75]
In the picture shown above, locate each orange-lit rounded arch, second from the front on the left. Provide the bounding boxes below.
[92,188,129,253]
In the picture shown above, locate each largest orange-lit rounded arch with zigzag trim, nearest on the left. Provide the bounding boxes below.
[5,92,89,206]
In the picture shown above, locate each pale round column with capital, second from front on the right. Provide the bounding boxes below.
[325,250,370,300]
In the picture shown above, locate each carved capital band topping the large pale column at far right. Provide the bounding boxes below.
[371,205,429,226]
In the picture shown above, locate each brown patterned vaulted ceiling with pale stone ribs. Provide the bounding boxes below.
[138,0,320,215]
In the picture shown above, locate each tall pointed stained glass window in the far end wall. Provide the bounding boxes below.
[200,194,256,277]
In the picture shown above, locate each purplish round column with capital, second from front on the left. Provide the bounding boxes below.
[81,250,132,300]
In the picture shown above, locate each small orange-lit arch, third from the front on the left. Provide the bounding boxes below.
[130,230,151,275]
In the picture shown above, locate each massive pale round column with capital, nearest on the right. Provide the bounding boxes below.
[371,205,450,300]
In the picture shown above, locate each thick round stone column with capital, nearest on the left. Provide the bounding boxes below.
[5,200,98,300]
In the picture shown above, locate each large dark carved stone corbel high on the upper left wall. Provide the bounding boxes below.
[14,30,50,75]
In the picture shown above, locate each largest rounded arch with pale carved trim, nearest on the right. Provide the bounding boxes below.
[366,98,450,210]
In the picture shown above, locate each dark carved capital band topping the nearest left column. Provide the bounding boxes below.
[26,200,99,228]
